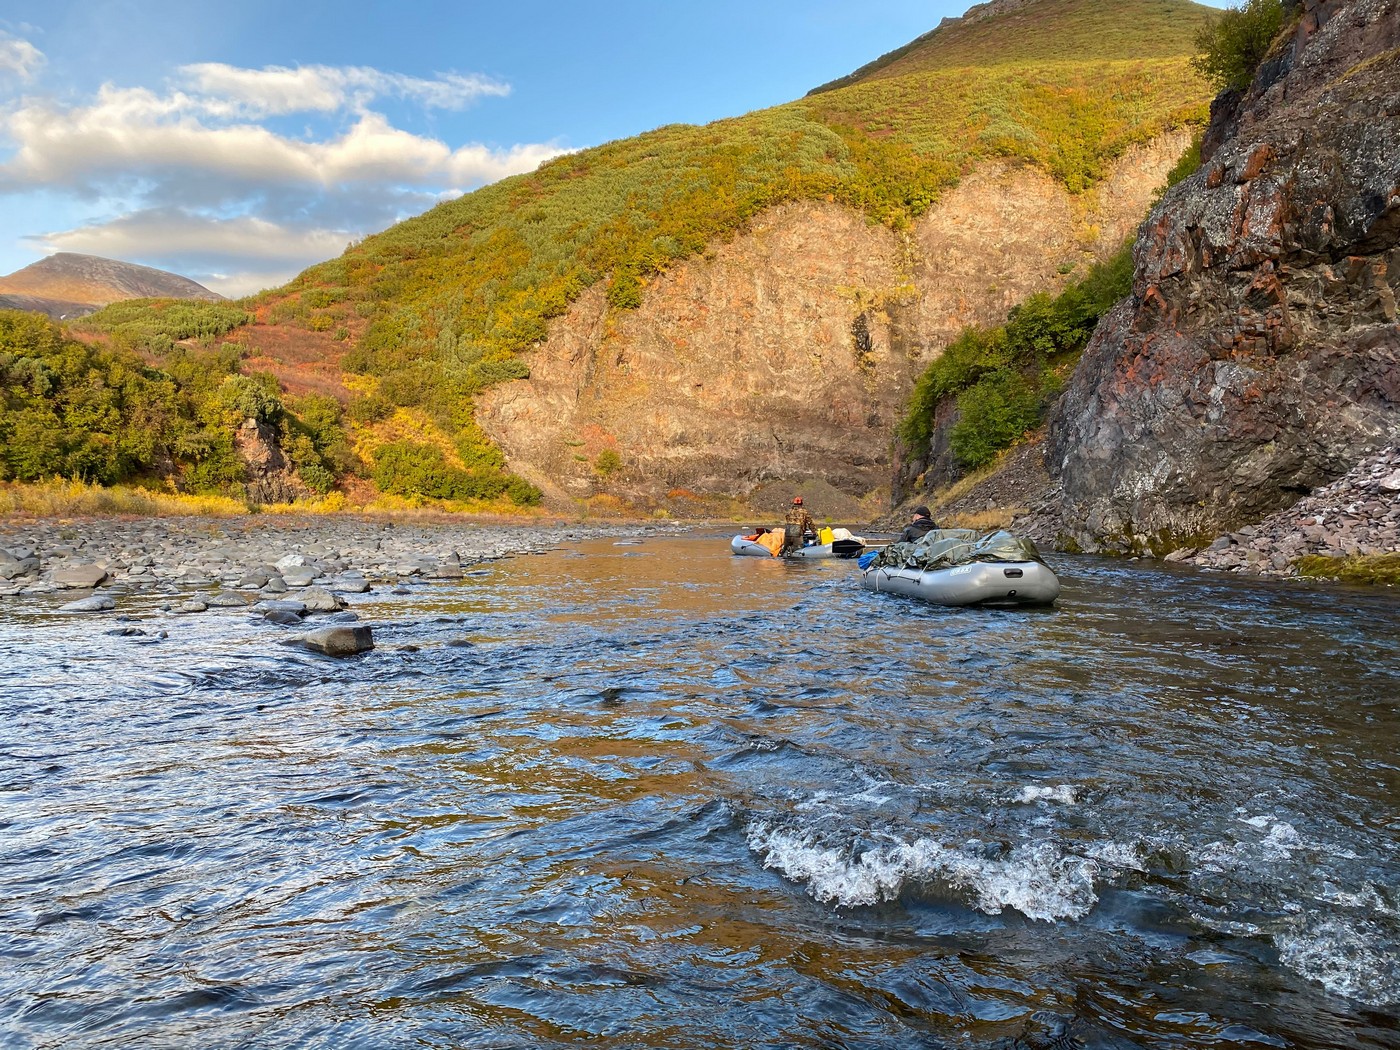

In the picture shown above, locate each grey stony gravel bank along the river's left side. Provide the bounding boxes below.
[0,515,683,615]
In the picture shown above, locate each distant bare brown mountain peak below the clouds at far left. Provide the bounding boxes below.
[0,252,224,321]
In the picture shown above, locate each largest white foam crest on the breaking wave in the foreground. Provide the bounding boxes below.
[748,822,1099,920]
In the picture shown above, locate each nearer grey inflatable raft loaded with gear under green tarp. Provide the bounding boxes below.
[860,529,1060,606]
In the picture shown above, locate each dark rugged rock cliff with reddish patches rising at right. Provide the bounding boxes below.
[1047,0,1400,550]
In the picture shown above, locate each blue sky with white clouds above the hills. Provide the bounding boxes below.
[0,0,1224,295]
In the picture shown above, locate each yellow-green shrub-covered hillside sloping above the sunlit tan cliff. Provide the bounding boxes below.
[68,0,1210,509]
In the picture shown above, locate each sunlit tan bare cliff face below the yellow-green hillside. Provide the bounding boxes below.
[476,133,1189,512]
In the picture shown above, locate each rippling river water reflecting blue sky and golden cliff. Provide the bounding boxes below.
[0,536,1400,1050]
